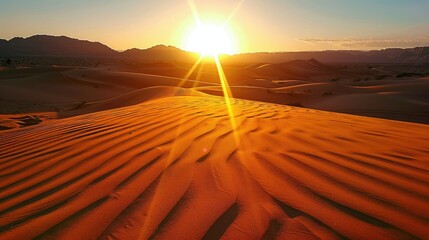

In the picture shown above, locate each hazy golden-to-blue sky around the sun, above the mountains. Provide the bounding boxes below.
[0,0,429,52]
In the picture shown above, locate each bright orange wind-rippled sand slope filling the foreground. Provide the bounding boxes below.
[0,96,429,239]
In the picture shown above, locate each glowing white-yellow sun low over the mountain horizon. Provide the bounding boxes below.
[184,23,236,56]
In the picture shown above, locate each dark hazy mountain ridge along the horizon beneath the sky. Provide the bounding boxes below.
[0,35,429,63]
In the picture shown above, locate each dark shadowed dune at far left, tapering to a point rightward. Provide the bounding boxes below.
[0,68,130,113]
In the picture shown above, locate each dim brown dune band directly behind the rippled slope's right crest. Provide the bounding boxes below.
[196,80,429,123]
